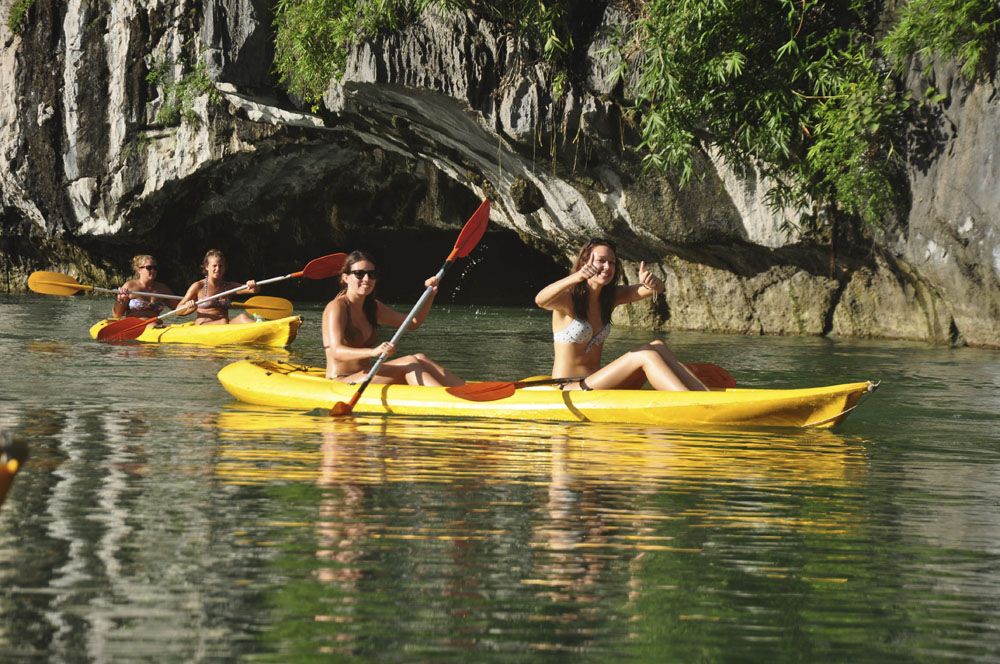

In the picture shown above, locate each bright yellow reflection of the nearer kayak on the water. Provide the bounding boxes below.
[216,404,866,498]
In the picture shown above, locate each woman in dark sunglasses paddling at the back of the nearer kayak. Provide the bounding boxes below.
[323,251,465,387]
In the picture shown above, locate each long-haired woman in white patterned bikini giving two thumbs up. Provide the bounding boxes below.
[535,239,708,391]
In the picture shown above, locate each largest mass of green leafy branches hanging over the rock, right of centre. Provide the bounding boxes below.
[604,0,907,228]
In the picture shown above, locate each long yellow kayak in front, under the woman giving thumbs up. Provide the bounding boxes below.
[219,360,876,428]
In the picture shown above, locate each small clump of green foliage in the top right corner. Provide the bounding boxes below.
[882,0,1000,79]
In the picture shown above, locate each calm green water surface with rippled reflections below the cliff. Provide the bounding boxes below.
[0,295,1000,664]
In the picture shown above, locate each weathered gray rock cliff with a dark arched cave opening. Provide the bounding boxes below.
[0,0,1000,347]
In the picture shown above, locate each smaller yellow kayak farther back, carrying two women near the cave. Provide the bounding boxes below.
[90,316,302,346]
